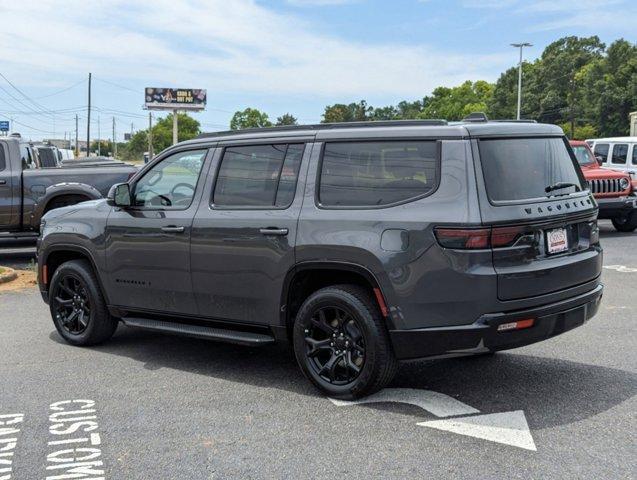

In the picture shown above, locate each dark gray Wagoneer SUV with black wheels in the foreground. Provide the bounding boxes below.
[38,119,602,398]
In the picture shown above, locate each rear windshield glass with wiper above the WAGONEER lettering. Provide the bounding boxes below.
[480,138,582,201]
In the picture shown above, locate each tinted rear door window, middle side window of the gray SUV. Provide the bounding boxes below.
[213,144,304,207]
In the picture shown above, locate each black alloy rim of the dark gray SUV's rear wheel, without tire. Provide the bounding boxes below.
[304,306,365,385]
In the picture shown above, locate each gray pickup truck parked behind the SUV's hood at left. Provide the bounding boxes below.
[0,138,137,236]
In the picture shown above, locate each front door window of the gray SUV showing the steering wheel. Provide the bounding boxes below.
[133,150,206,209]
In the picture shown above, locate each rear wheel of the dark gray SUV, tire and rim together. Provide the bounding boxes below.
[293,285,398,399]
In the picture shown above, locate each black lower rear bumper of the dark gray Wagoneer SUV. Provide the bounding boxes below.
[389,284,604,360]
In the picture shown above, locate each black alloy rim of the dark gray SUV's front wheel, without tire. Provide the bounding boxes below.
[51,274,91,335]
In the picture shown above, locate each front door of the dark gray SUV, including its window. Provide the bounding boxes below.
[106,149,207,314]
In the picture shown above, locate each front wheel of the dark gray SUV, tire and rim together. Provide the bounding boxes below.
[49,260,118,346]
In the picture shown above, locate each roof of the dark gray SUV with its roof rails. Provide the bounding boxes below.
[178,120,564,148]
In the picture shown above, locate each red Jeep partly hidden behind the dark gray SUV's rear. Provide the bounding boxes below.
[571,140,637,232]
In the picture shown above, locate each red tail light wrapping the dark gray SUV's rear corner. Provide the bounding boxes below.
[434,226,524,250]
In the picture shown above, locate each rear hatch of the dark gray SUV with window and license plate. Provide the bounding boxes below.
[474,137,602,300]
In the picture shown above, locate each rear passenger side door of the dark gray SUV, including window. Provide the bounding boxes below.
[191,141,310,324]
